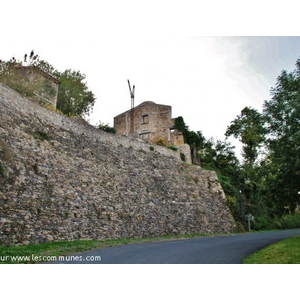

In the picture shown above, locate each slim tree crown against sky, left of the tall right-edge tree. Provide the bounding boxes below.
[225,107,266,166]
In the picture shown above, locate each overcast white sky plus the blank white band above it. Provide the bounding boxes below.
[0,0,300,159]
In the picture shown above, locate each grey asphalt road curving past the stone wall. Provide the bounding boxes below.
[59,229,300,264]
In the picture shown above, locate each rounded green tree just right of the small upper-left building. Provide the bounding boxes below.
[56,70,96,117]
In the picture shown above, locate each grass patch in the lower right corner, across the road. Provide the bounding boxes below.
[243,236,300,264]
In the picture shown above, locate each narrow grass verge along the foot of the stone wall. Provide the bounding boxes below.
[0,234,213,264]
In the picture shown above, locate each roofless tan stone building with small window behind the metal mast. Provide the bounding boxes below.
[114,101,184,146]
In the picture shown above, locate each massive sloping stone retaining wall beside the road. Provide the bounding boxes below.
[0,83,235,245]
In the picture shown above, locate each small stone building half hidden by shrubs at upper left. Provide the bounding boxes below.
[15,65,60,108]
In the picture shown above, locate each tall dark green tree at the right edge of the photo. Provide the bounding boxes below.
[264,59,300,213]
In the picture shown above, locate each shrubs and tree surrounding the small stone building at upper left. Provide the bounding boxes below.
[0,50,96,117]
